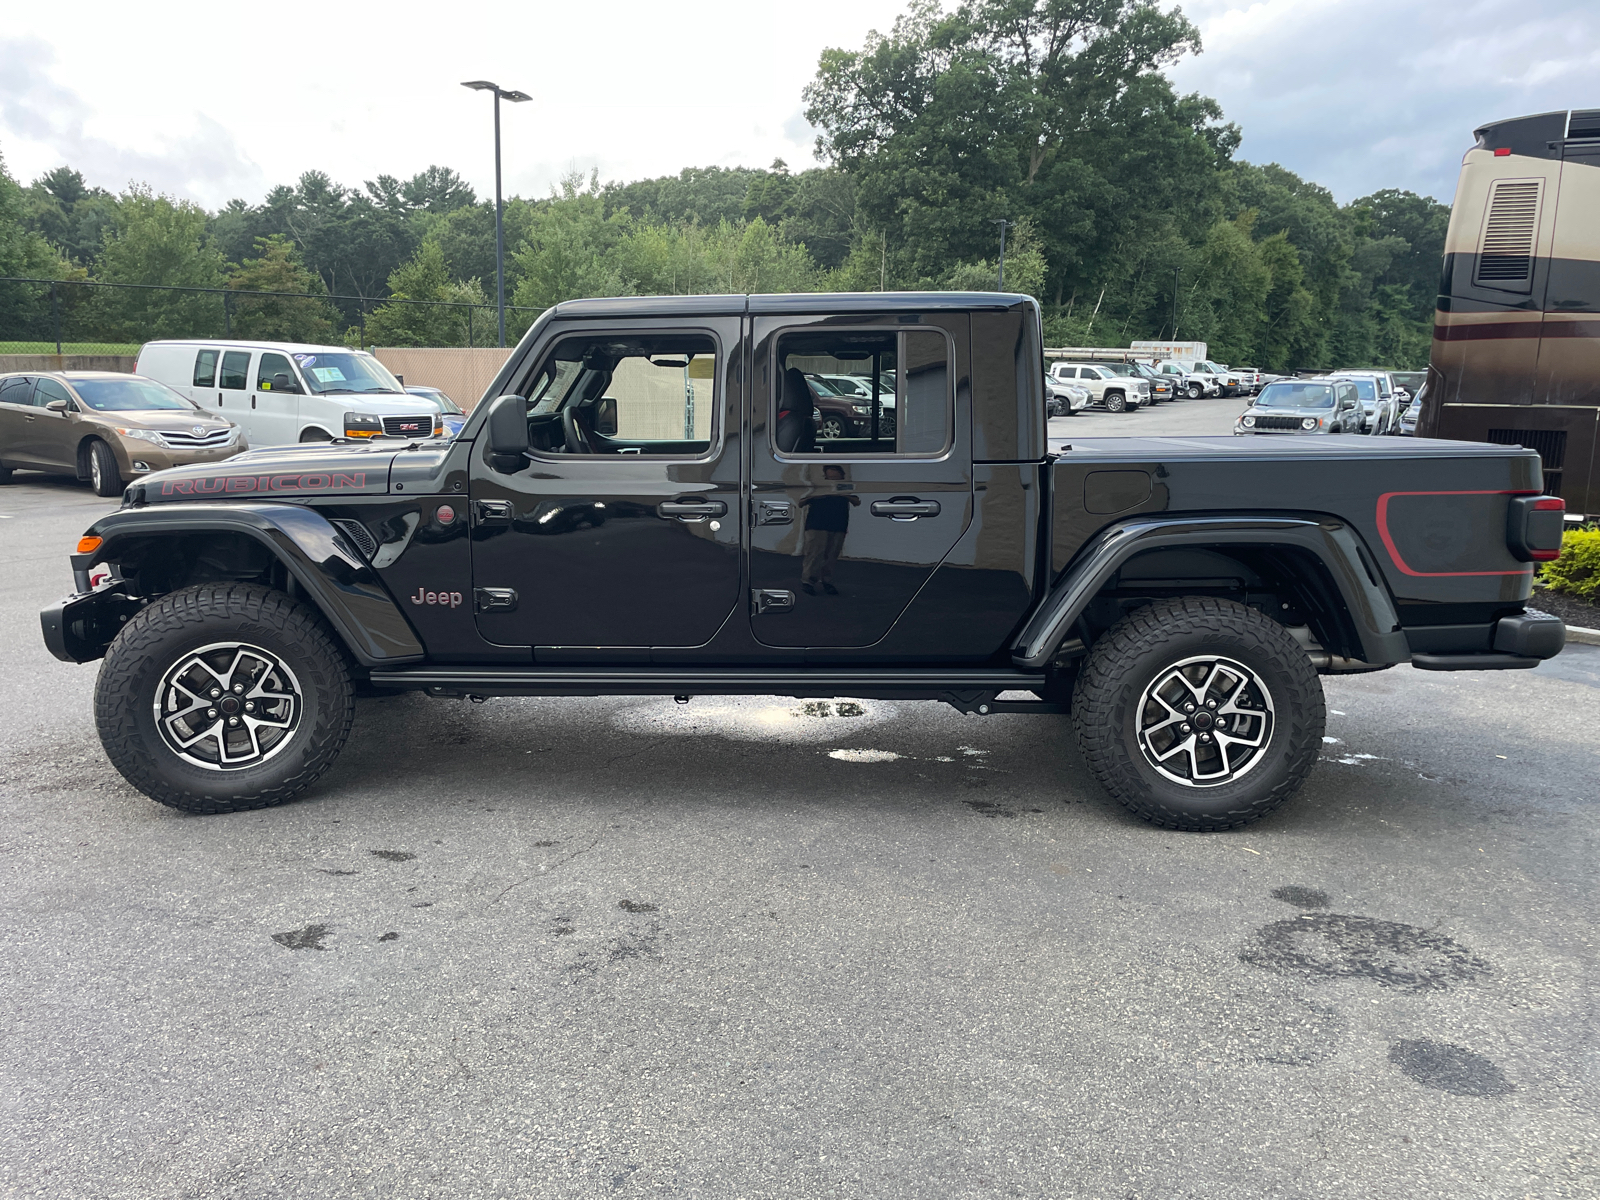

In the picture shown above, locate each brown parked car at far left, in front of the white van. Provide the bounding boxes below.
[0,371,248,496]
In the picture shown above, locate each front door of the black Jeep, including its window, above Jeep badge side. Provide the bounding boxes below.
[470,317,742,662]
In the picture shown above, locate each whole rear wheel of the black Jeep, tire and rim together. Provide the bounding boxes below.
[1072,597,1326,830]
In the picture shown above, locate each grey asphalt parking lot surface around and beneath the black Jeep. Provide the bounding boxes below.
[0,400,1600,1200]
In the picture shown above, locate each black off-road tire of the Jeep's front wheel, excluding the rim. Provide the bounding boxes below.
[94,584,355,813]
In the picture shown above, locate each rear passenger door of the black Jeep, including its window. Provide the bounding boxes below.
[750,314,973,654]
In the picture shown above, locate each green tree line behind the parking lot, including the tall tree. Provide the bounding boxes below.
[0,0,1450,370]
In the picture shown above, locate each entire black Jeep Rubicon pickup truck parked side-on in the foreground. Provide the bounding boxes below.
[42,293,1565,830]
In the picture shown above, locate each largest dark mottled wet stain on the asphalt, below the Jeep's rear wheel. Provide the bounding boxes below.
[1238,912,1490,992]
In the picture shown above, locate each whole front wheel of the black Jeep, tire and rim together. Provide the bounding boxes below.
[94,584,354,813]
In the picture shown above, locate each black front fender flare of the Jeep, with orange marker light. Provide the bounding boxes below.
[84,504,426,667]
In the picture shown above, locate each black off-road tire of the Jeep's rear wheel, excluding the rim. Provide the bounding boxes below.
[1072,595,1326,832]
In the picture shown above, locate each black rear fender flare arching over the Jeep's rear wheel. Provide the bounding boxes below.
[1011,514,1411,670]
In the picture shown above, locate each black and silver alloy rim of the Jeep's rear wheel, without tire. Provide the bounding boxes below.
[1138,654,1272,787]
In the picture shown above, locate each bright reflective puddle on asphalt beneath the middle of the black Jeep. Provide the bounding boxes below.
[611,696,896,742]
